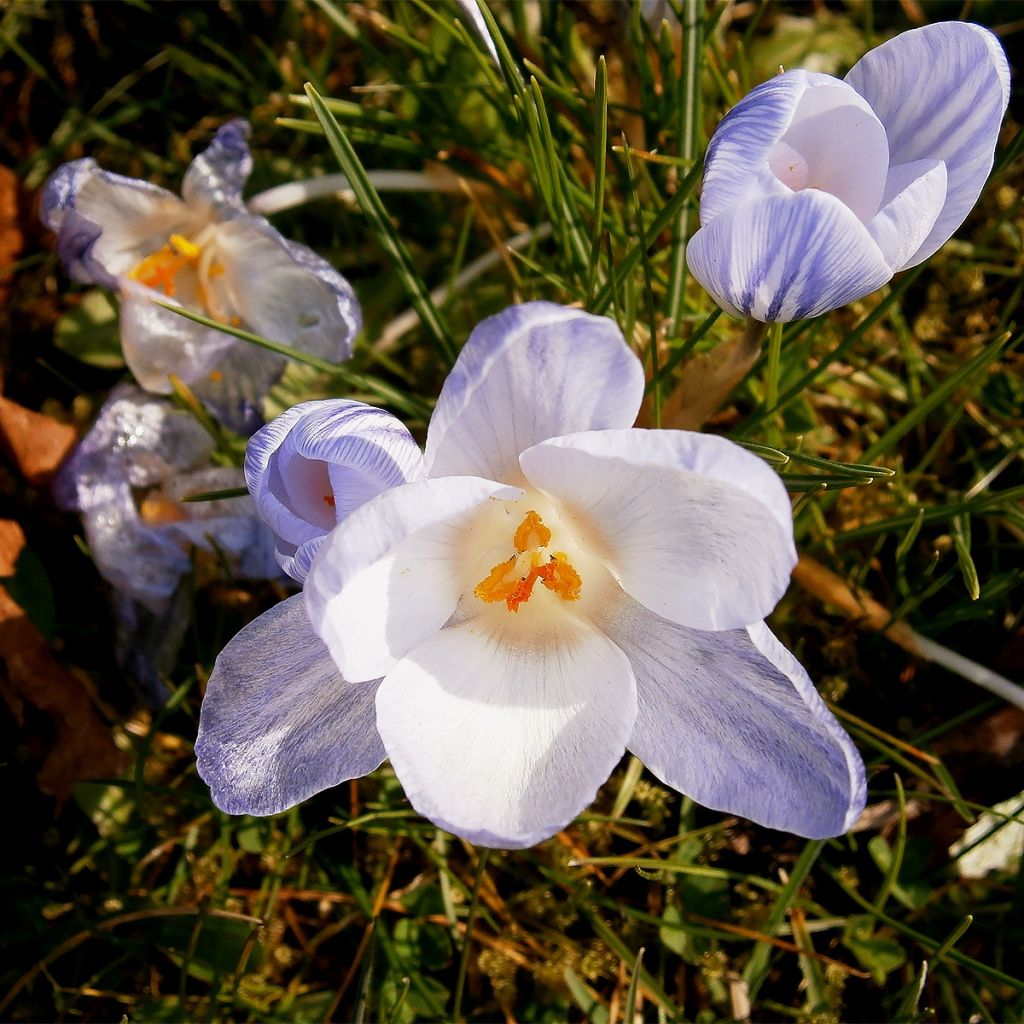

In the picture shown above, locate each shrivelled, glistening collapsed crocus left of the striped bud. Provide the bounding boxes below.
[54,384,279,614]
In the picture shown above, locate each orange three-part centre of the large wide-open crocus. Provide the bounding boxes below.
[473,510,583,611]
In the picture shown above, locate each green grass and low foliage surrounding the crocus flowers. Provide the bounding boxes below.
[6,0,1024,1024]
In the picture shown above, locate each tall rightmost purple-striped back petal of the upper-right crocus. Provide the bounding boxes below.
[846,22,1010,266]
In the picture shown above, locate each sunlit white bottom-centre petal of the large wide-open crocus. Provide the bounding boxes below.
[377,615,636,849]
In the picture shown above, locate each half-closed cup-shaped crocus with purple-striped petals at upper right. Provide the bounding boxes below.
[686,22,1010,322]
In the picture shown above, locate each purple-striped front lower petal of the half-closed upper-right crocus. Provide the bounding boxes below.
[686,188,892,323]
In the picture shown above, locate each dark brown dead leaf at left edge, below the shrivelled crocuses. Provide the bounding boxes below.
[0,519,124,801]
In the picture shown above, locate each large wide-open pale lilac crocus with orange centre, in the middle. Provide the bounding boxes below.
[196,302,864,848]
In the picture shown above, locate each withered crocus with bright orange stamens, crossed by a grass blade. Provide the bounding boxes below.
[42,120,360,433]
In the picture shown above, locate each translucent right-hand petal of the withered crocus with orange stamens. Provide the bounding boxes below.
[210,215,361,360]
